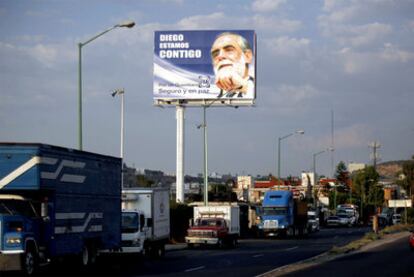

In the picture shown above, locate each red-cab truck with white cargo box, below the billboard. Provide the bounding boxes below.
[185,205,240,248]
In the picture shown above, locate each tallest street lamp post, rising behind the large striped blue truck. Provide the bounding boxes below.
[78,21,135,150]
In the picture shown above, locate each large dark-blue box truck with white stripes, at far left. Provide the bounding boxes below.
[0,143,121,275]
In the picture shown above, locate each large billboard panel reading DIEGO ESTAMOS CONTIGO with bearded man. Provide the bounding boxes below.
[153,30,256,105]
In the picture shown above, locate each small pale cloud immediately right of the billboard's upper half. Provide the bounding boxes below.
[265,36,310,57]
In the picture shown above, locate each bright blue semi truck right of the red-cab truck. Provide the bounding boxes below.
[257,190,308,237]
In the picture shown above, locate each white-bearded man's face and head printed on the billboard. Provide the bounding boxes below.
[211,35,252,77]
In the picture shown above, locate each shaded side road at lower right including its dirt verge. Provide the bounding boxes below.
[264,232,414,277]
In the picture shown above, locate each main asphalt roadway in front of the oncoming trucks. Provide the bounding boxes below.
[4,225,369,276]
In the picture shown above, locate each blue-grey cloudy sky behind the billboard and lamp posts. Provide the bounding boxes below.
[0,0,414,176]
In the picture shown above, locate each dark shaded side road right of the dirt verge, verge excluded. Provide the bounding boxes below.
[284,232,414,277]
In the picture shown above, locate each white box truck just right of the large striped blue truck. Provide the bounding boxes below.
[121,188,170,257]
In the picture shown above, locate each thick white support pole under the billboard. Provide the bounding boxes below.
[175,106,184,203]
